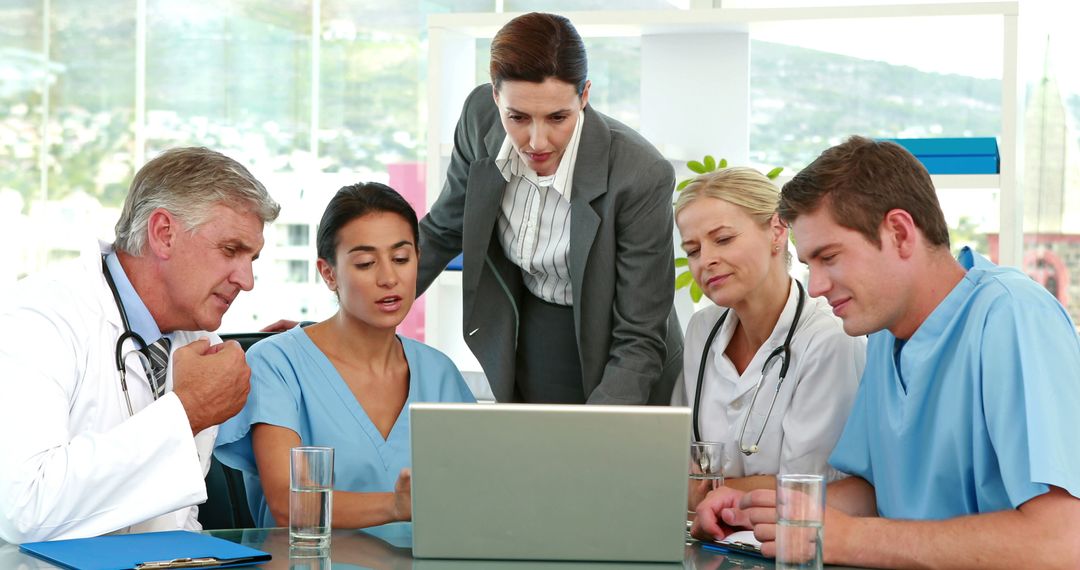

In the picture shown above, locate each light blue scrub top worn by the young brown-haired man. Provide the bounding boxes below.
[829,248,1080,519]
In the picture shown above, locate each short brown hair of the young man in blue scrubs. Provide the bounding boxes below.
[777,136,948,247]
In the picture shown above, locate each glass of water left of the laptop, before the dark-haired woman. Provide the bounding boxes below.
[288,447,334,549]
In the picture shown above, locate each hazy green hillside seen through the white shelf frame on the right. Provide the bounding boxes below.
[751,41,1002,172]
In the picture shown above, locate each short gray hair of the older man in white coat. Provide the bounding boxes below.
[112,147,281,256]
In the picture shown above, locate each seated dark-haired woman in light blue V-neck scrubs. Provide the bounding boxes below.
[216,182,475,528]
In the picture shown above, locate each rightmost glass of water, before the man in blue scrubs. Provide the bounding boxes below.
[777,474,825,570]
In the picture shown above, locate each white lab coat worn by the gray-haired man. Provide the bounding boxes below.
[0,244,219,543]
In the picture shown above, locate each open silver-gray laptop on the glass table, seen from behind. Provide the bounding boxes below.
[409,404,690,562]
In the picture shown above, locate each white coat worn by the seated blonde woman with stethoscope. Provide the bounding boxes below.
[672,282,866,480]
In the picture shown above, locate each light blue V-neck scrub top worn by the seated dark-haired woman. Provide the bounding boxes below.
[215,327,476,527]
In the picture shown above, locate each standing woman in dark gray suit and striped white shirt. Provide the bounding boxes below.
[418,13,683,404]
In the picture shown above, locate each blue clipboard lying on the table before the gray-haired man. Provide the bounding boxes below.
[18,530,270,570]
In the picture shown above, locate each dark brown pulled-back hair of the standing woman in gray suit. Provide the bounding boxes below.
[491,12,589,95]
